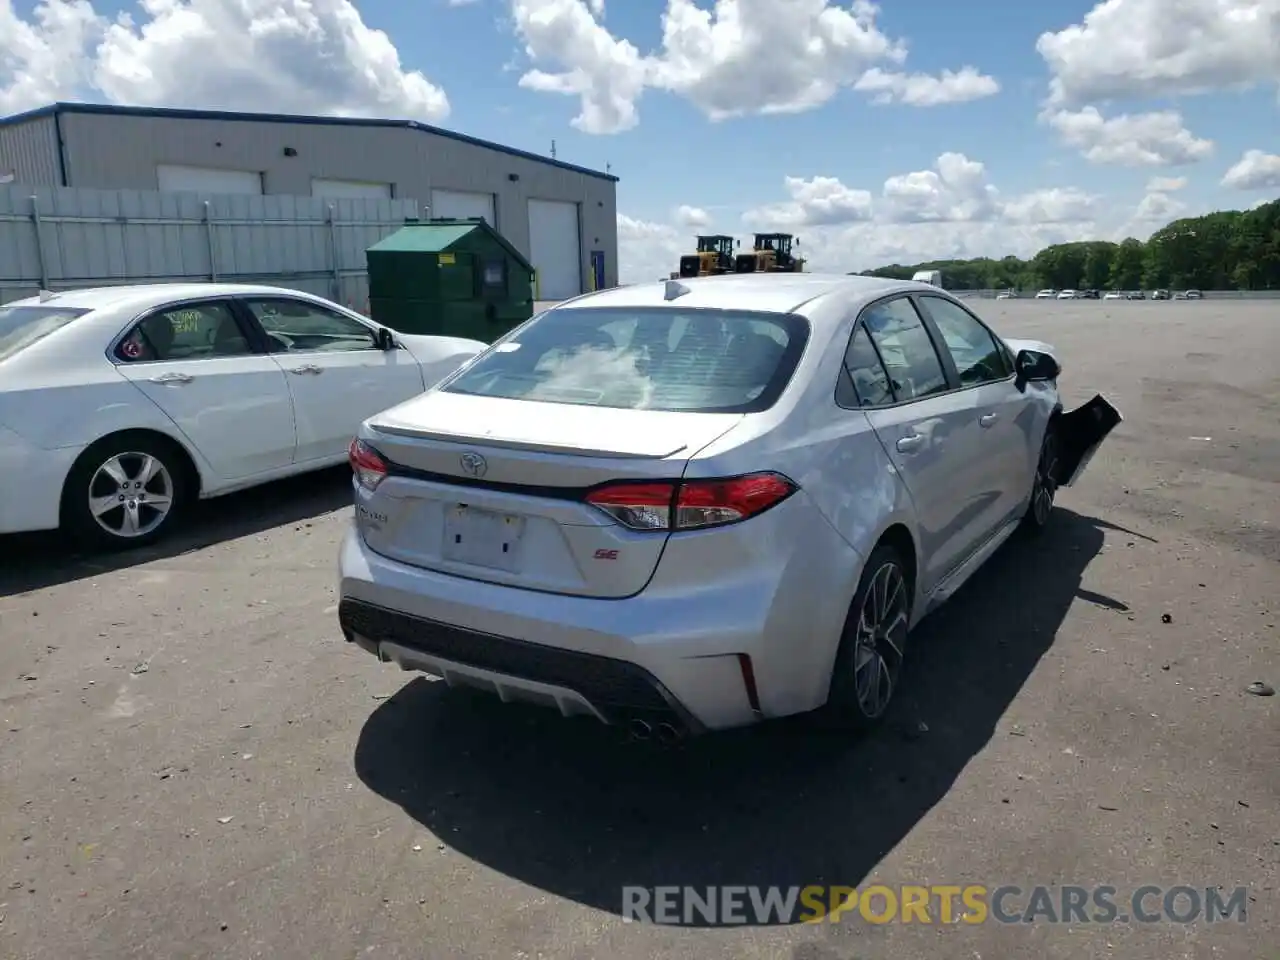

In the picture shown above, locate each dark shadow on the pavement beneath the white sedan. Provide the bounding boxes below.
[0,465,351,598]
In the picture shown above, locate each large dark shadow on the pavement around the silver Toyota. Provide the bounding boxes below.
[355,508,1146,913]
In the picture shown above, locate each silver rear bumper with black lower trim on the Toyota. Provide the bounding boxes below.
[339,525,847,736]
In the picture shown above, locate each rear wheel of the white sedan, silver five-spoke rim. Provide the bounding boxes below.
[61,431,191,550]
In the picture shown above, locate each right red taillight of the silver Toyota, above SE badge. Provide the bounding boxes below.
[586,472,797,531]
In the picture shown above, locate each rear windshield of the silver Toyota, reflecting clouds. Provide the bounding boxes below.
[443,307,809,413]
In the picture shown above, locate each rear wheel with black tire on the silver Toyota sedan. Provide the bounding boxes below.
[823,544,915,732]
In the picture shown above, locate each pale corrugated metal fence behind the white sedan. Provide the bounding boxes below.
[0,186,419,310]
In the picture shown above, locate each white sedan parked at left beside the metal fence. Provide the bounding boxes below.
[0,283,486,547]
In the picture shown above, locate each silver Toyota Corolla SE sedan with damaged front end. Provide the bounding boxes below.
[339,274,1120,740]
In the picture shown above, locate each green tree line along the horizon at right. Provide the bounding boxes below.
[863,200,1280,291]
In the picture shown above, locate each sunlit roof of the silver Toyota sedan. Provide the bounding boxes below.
[553,274,941,314]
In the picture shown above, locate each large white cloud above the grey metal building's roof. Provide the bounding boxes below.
[0,0,449,120]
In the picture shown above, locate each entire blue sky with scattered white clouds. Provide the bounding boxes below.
[0,0,1280,275]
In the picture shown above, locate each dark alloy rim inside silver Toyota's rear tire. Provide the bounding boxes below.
[854,563,910,719]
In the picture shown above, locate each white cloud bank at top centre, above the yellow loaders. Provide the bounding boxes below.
[512,0,998,133]
